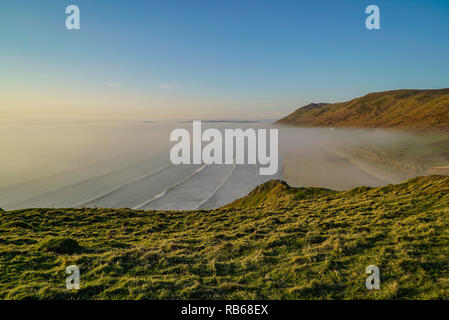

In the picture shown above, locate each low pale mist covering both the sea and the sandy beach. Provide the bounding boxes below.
[0,121,438,210]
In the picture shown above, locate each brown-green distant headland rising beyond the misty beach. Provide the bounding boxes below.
[276,89,449,131]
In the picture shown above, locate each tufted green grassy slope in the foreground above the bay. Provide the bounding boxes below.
[0,176,449,299]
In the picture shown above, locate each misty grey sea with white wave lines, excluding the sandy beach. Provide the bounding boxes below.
[0,122,280,209]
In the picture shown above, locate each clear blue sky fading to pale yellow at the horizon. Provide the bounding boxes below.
[0,0,449,122]
